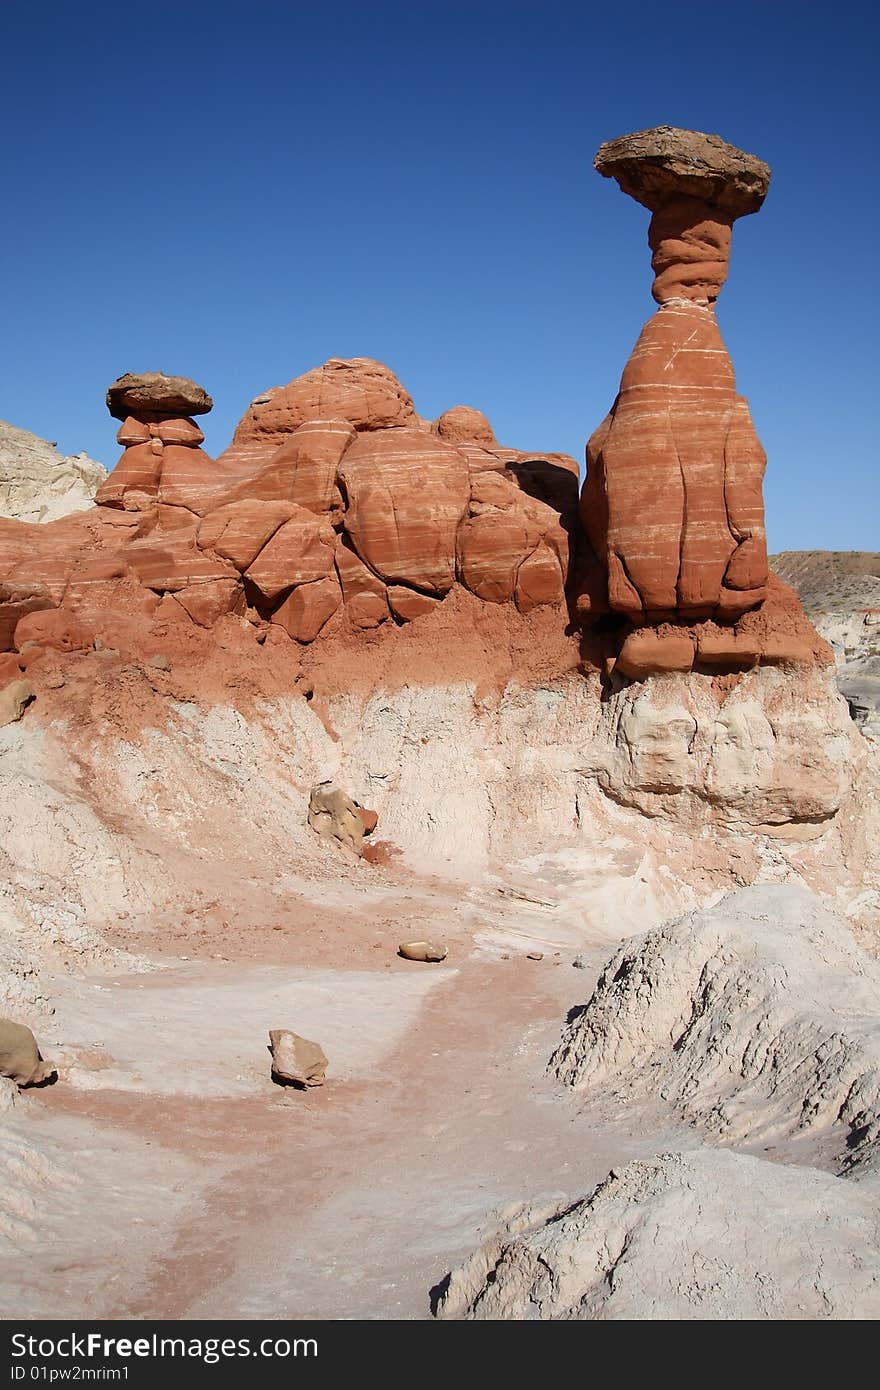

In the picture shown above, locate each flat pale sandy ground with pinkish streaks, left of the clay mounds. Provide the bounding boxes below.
[1,949,664,1318]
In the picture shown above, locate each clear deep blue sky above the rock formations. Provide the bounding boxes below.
[0,0,880,549]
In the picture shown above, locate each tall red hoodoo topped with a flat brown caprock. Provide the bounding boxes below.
[581,126,770,670]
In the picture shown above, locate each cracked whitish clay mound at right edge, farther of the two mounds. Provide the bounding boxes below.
[551,885,880,1168]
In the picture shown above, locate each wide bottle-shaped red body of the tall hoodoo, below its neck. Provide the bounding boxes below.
[581,303,766,616]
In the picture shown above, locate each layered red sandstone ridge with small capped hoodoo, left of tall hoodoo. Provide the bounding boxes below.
[0,359,577,677]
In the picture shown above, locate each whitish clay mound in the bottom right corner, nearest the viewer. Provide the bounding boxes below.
[437,1150,880,1321]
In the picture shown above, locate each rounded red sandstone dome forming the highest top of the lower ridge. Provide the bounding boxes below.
[221,357,414,466]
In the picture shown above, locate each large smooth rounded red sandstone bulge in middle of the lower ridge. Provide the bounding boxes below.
[339,430,470,594]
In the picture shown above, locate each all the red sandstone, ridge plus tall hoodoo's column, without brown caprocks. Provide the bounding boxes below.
[0,339,831,680]
